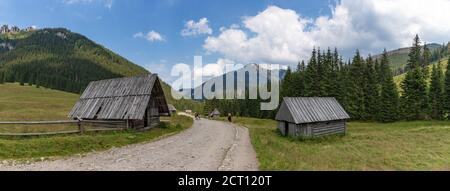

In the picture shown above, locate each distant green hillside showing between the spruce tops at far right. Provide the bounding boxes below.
[373,43,443,75]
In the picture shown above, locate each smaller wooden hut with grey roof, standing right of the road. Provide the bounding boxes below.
[276,97,350,137]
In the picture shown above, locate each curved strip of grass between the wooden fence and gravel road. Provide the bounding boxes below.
[0,116,193,160]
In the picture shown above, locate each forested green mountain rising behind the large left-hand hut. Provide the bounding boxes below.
[0,28,201,112]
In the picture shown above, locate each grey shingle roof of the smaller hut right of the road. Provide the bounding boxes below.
[276,97,350,124]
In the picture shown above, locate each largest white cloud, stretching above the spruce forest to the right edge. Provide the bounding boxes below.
[203,0,450,65]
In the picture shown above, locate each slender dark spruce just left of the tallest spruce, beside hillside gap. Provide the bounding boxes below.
[377,49,399,122]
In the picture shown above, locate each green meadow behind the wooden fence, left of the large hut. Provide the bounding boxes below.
[0,83,80,133]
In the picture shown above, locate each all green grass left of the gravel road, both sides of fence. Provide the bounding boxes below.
[0,84,193,159]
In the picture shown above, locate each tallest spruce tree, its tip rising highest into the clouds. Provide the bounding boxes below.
[401,35,428,120]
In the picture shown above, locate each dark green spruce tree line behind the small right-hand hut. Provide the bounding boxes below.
[204,35,450,122]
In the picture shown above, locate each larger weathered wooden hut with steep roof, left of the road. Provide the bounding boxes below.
[69,74,170,129]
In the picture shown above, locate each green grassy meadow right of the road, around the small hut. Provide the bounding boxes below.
[227,118,450,171]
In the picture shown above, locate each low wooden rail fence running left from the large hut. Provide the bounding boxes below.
[0,120,128,136]
